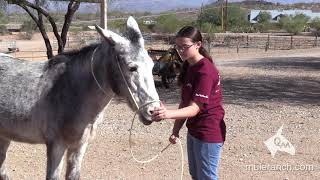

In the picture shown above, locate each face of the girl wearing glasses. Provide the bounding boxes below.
[175,37,201,60]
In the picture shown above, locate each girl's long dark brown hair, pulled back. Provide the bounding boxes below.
[176,26,213,86]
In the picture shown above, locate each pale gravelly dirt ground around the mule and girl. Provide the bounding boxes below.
[0,33,320,180]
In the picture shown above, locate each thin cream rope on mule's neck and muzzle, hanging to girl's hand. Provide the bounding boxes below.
[91,48,184,180]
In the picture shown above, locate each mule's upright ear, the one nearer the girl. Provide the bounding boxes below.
[127,16,144,44]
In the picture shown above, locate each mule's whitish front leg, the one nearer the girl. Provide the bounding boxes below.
[66,141,88,180]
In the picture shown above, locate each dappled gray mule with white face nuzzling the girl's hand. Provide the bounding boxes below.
[0,17,159,179]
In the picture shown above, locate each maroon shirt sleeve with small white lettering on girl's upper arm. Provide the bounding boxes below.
[192,72,215,104]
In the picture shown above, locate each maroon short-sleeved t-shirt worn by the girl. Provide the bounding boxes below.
[182,58,226,143]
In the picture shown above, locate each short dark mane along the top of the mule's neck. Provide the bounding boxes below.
[46,43,99,69]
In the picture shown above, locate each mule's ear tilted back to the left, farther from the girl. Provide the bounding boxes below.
[95,25,129,45]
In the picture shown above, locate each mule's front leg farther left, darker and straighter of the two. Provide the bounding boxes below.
[46,142,66,180]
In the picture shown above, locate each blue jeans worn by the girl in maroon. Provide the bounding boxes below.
[187,133,223,180]
